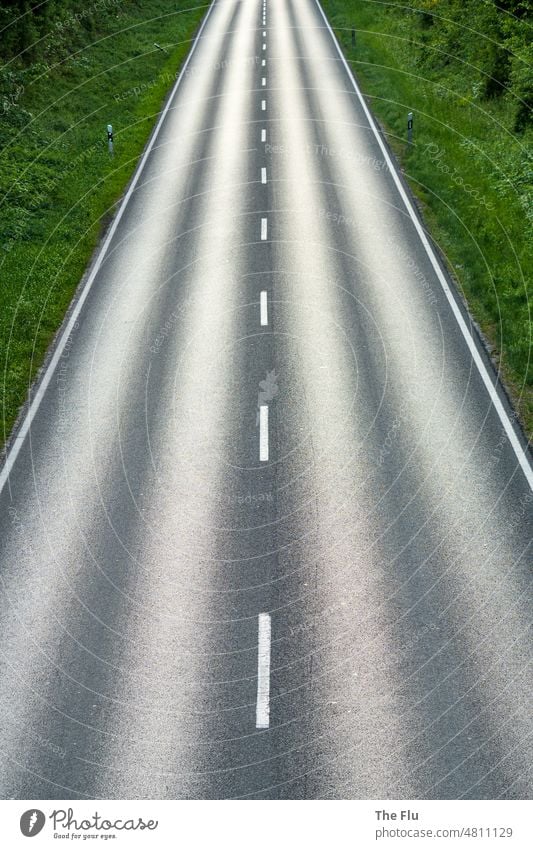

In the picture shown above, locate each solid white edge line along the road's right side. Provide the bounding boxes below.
[315,0,533,490]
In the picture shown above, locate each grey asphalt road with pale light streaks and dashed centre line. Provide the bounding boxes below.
[0,0,533,799]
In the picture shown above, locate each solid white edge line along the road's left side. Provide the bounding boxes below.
[0,0,216,493]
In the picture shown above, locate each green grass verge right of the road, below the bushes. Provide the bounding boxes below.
[322,0,533,437]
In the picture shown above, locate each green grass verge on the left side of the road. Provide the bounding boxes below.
[0,0,209,445]
